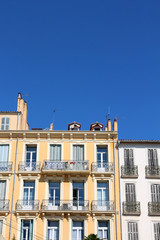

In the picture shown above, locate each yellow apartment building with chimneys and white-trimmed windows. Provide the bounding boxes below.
[0,94,121,240]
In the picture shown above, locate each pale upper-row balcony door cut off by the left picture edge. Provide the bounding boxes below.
[0,145,9,171]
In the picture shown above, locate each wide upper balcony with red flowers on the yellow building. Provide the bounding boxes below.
[42,160,89,174]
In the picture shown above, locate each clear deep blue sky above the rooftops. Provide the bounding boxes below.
[0,0,160,139]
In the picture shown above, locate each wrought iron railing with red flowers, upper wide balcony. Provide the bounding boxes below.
[43,160,89,171]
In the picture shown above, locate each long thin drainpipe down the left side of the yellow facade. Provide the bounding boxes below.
[9,112,19,240]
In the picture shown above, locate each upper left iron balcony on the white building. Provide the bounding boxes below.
[121,165,138,178]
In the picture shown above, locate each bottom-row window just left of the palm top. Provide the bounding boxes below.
[72,221,84,240]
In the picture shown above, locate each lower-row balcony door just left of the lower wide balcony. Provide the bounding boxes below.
[23,181,35,210]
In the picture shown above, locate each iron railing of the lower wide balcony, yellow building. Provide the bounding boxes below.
[42,200,89,211]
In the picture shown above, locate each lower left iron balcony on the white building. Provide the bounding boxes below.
[123,202,141,216]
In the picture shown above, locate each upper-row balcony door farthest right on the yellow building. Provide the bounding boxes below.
[97,146,108,171]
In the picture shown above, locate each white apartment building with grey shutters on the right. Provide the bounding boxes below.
[118,140,160,240]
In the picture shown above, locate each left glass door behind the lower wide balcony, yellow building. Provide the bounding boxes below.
[49,182,60,210]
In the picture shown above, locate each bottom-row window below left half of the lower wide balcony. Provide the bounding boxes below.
[47,221,59,240]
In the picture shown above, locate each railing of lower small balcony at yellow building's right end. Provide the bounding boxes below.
[92,200,114,212]
